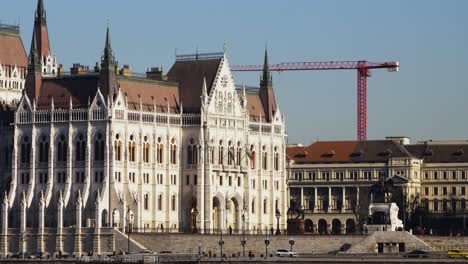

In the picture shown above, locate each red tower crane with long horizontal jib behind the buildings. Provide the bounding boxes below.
[231,60,400,141]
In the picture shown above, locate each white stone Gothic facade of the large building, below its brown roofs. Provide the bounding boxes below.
[8,53,287,232]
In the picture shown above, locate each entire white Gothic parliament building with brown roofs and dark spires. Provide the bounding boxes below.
[0,0,288,233]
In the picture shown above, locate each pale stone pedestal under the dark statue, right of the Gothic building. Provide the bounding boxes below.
[367,203,403,232]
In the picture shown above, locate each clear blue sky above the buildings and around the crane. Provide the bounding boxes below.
[0,0,468,143]
